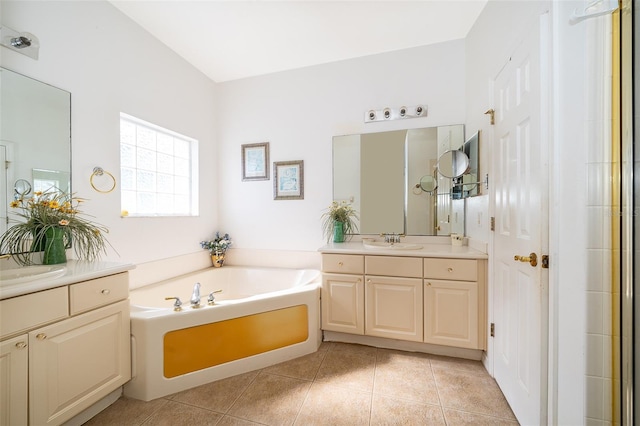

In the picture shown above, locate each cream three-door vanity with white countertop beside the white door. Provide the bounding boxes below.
[320,242,487,357]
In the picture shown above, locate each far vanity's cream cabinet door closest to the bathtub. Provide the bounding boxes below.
[321,274,364,334]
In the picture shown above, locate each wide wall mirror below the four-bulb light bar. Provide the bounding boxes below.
[333,124,464,235]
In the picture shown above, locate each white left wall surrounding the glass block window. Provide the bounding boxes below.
[0,0,219,263]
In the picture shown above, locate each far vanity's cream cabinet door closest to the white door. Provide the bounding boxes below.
[424,279,482,349]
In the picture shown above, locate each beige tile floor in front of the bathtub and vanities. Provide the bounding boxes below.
[85,342,518,426]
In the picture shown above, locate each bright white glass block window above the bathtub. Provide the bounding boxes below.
[120,113,198,216]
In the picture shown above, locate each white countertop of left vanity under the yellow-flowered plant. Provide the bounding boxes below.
[0,260,135,300]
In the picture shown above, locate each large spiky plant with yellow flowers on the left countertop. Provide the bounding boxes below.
[0,191,109,266]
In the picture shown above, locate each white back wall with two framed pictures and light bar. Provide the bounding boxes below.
[218,40,465,251]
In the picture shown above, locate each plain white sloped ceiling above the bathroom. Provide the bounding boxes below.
[111,0,487,82]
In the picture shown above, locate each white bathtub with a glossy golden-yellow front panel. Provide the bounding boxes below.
[124,266,322,401]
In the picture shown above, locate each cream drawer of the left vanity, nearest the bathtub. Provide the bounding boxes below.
[69,272,129,315]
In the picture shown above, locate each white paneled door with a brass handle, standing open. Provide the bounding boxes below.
[492,14,548,425]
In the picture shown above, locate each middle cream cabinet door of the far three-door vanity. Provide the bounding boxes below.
[365,276,423,342]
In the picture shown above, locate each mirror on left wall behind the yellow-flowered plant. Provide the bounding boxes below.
[0,68,71,243]
